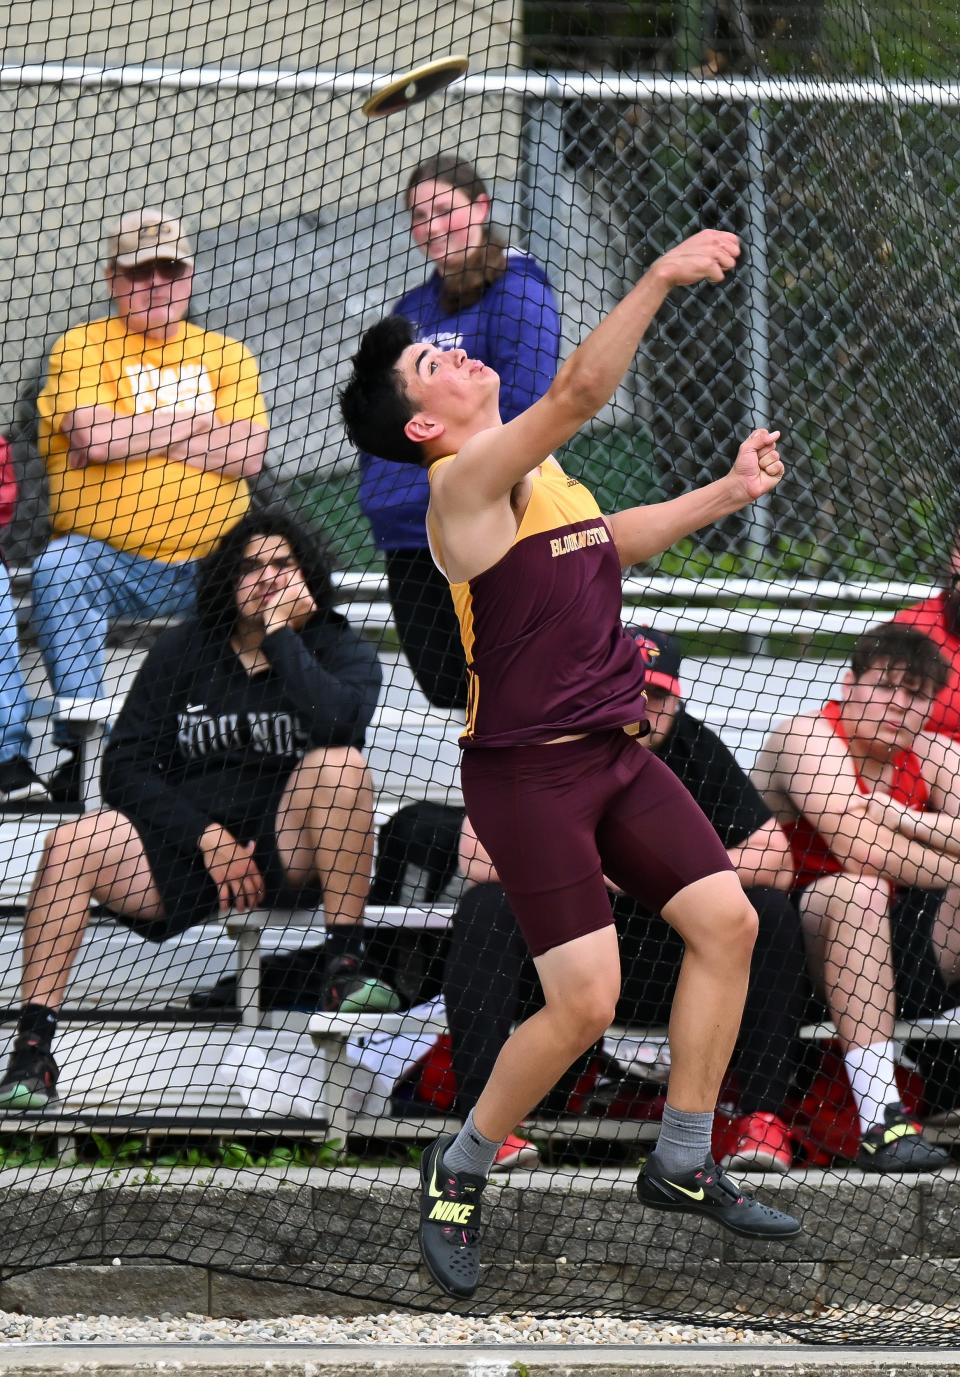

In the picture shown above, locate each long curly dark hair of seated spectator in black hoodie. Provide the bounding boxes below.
[197,511,333,636]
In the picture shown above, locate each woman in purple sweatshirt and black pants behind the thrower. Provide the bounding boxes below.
[359,153,561,708]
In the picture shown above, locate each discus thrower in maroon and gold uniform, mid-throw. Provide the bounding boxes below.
[340,230,800,1296]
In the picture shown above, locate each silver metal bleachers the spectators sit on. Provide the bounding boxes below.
[0,573,960,1150]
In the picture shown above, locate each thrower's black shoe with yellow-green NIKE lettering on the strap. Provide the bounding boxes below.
[419,1133,486,1300]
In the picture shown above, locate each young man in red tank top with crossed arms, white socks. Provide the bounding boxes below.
[752,622,960,1172]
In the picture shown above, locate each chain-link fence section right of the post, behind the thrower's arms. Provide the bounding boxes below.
[526,90,960,578]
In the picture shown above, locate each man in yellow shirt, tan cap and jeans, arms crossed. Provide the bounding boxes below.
[33,207,267,801]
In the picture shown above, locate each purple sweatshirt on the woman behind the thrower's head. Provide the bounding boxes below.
[359,249,561,549]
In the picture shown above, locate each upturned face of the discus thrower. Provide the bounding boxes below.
[397,340,500,443]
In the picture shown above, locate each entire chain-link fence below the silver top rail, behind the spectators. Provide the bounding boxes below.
[0,72,960,578]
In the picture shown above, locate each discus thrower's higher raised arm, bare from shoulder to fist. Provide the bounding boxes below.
[444,230,740,507]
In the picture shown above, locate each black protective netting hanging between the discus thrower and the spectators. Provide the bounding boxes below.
[0,0,960,1345]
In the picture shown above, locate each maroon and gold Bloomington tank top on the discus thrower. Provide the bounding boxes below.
[427,456,646,746]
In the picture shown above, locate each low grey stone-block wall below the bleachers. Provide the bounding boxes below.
[0,1166,960,1327]
